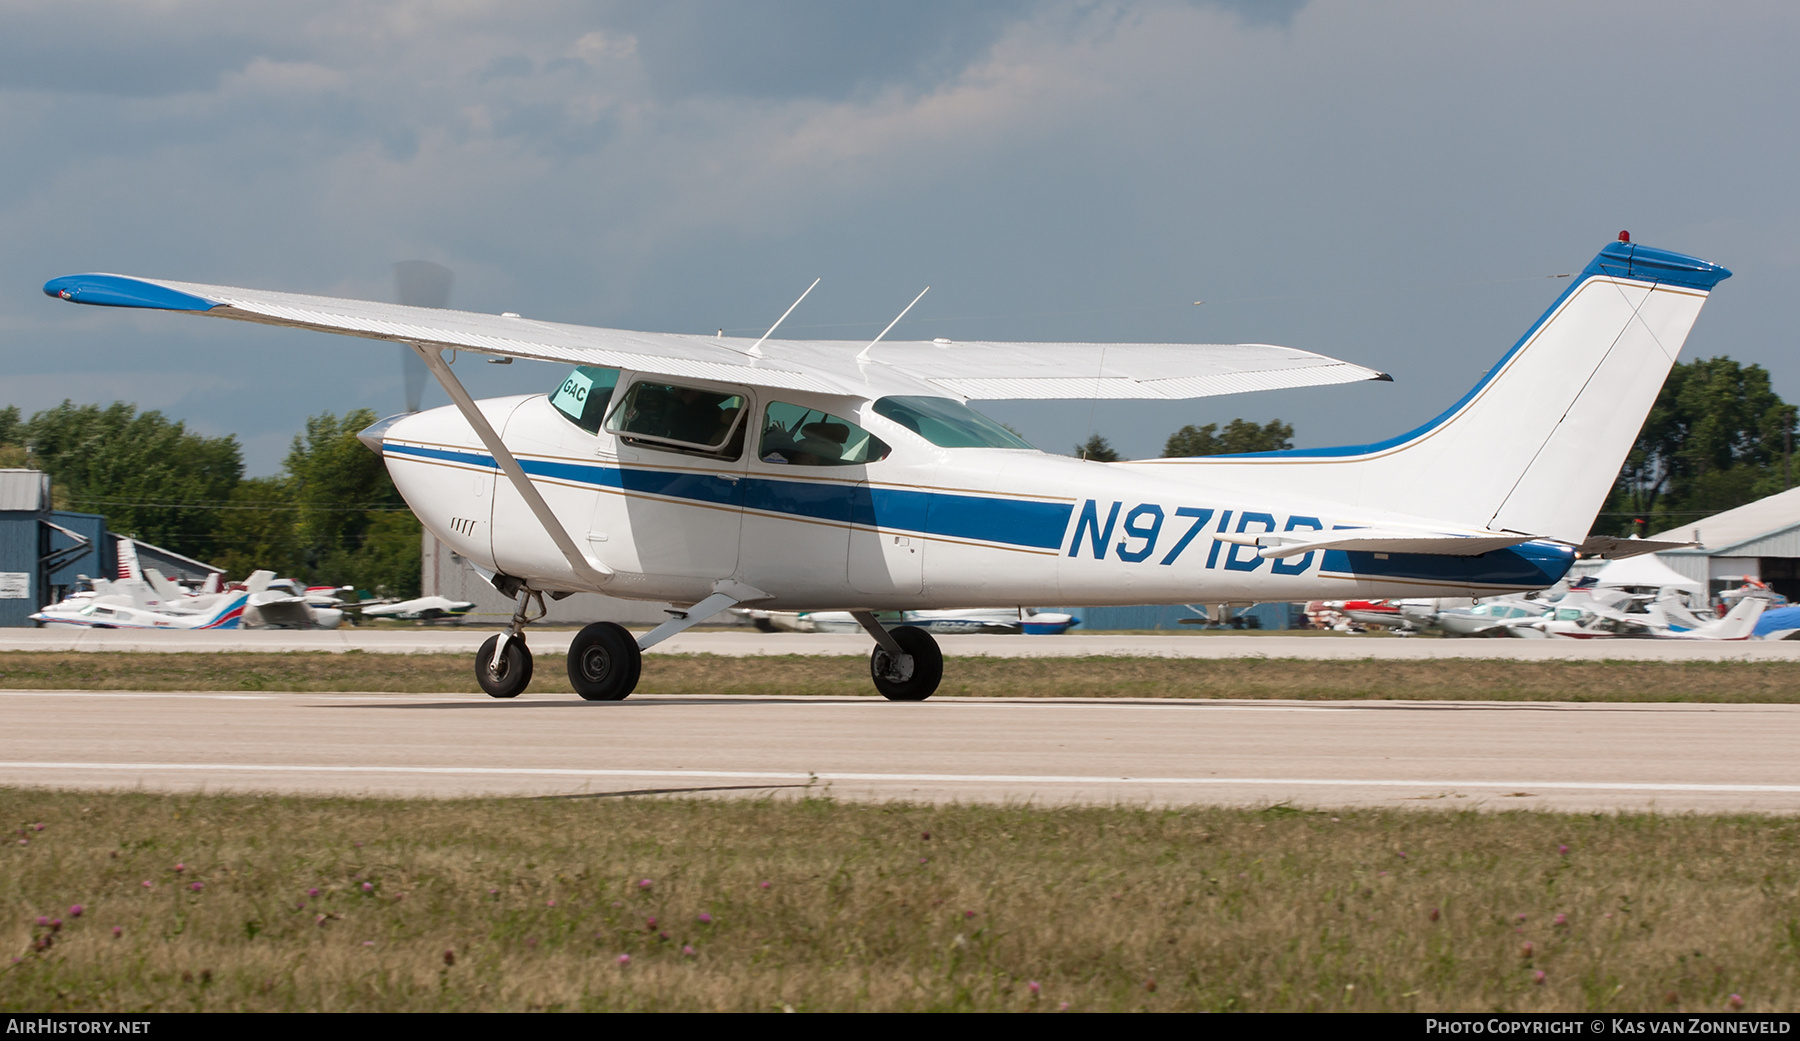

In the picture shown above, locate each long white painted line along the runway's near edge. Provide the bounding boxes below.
[0,762,1800,794]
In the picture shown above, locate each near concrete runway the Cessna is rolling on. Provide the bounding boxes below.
[0,690,1800,814]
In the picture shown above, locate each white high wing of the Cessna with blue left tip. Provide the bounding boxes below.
[43,274,1390,400]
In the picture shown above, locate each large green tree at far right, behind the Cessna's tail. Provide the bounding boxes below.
[1595,357,1795,535]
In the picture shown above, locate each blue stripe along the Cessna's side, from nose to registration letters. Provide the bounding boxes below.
[385,443,1075,549]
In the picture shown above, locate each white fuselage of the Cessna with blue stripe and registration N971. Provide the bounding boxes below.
[382,387,1573,611]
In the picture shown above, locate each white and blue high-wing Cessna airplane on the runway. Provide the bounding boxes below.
[43,234,1730,701]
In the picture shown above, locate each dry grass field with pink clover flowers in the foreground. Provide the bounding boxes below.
[0,791,1800,1012]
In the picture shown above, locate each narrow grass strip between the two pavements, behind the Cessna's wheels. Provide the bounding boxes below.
[0,652,1800,704]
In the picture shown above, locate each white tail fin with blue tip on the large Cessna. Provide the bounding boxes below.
[1137,236,1732,544]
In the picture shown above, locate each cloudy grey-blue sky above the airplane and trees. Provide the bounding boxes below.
[0,0,1800,474]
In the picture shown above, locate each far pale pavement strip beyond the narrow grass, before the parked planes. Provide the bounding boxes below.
[0,627,1800,661]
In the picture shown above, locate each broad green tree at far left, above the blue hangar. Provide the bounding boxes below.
[14,400,243,558]
